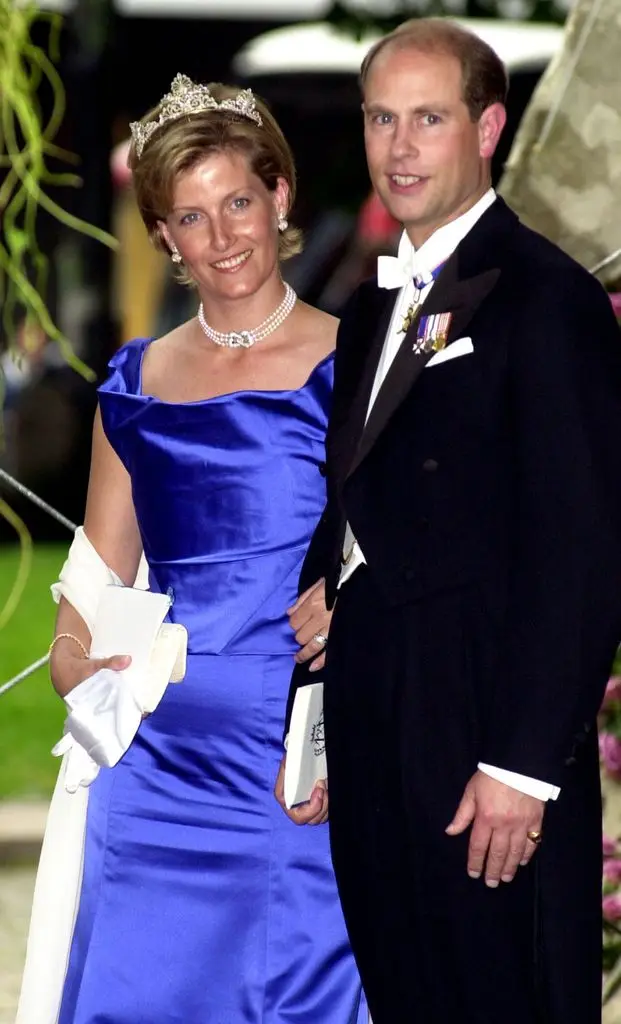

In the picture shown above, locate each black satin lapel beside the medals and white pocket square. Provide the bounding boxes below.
[347,252,500,475]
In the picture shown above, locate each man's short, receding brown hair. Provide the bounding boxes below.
[360,17,508,121]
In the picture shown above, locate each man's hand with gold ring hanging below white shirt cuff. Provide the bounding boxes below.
[447,771,545,888]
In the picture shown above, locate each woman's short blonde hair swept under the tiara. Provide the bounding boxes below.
[128,82,302,266]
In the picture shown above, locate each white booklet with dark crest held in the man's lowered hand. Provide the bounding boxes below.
[285,683,328,807]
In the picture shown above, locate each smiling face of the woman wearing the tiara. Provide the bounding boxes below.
[160,150,289,299]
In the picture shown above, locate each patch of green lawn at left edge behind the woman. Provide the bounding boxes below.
[0,545,67,800]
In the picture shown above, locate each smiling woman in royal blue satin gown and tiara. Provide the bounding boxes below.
[38,76,366,1024]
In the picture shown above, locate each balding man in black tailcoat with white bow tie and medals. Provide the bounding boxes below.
[279,19,621,1024]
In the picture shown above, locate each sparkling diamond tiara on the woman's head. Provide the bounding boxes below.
[129,75,263,160]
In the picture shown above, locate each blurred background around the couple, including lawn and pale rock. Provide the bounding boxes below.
[0,0,621,1024]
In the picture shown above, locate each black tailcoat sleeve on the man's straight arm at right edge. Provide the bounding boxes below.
[480,268,621,785]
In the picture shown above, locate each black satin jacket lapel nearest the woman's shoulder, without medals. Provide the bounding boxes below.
[328,289,398,484]
